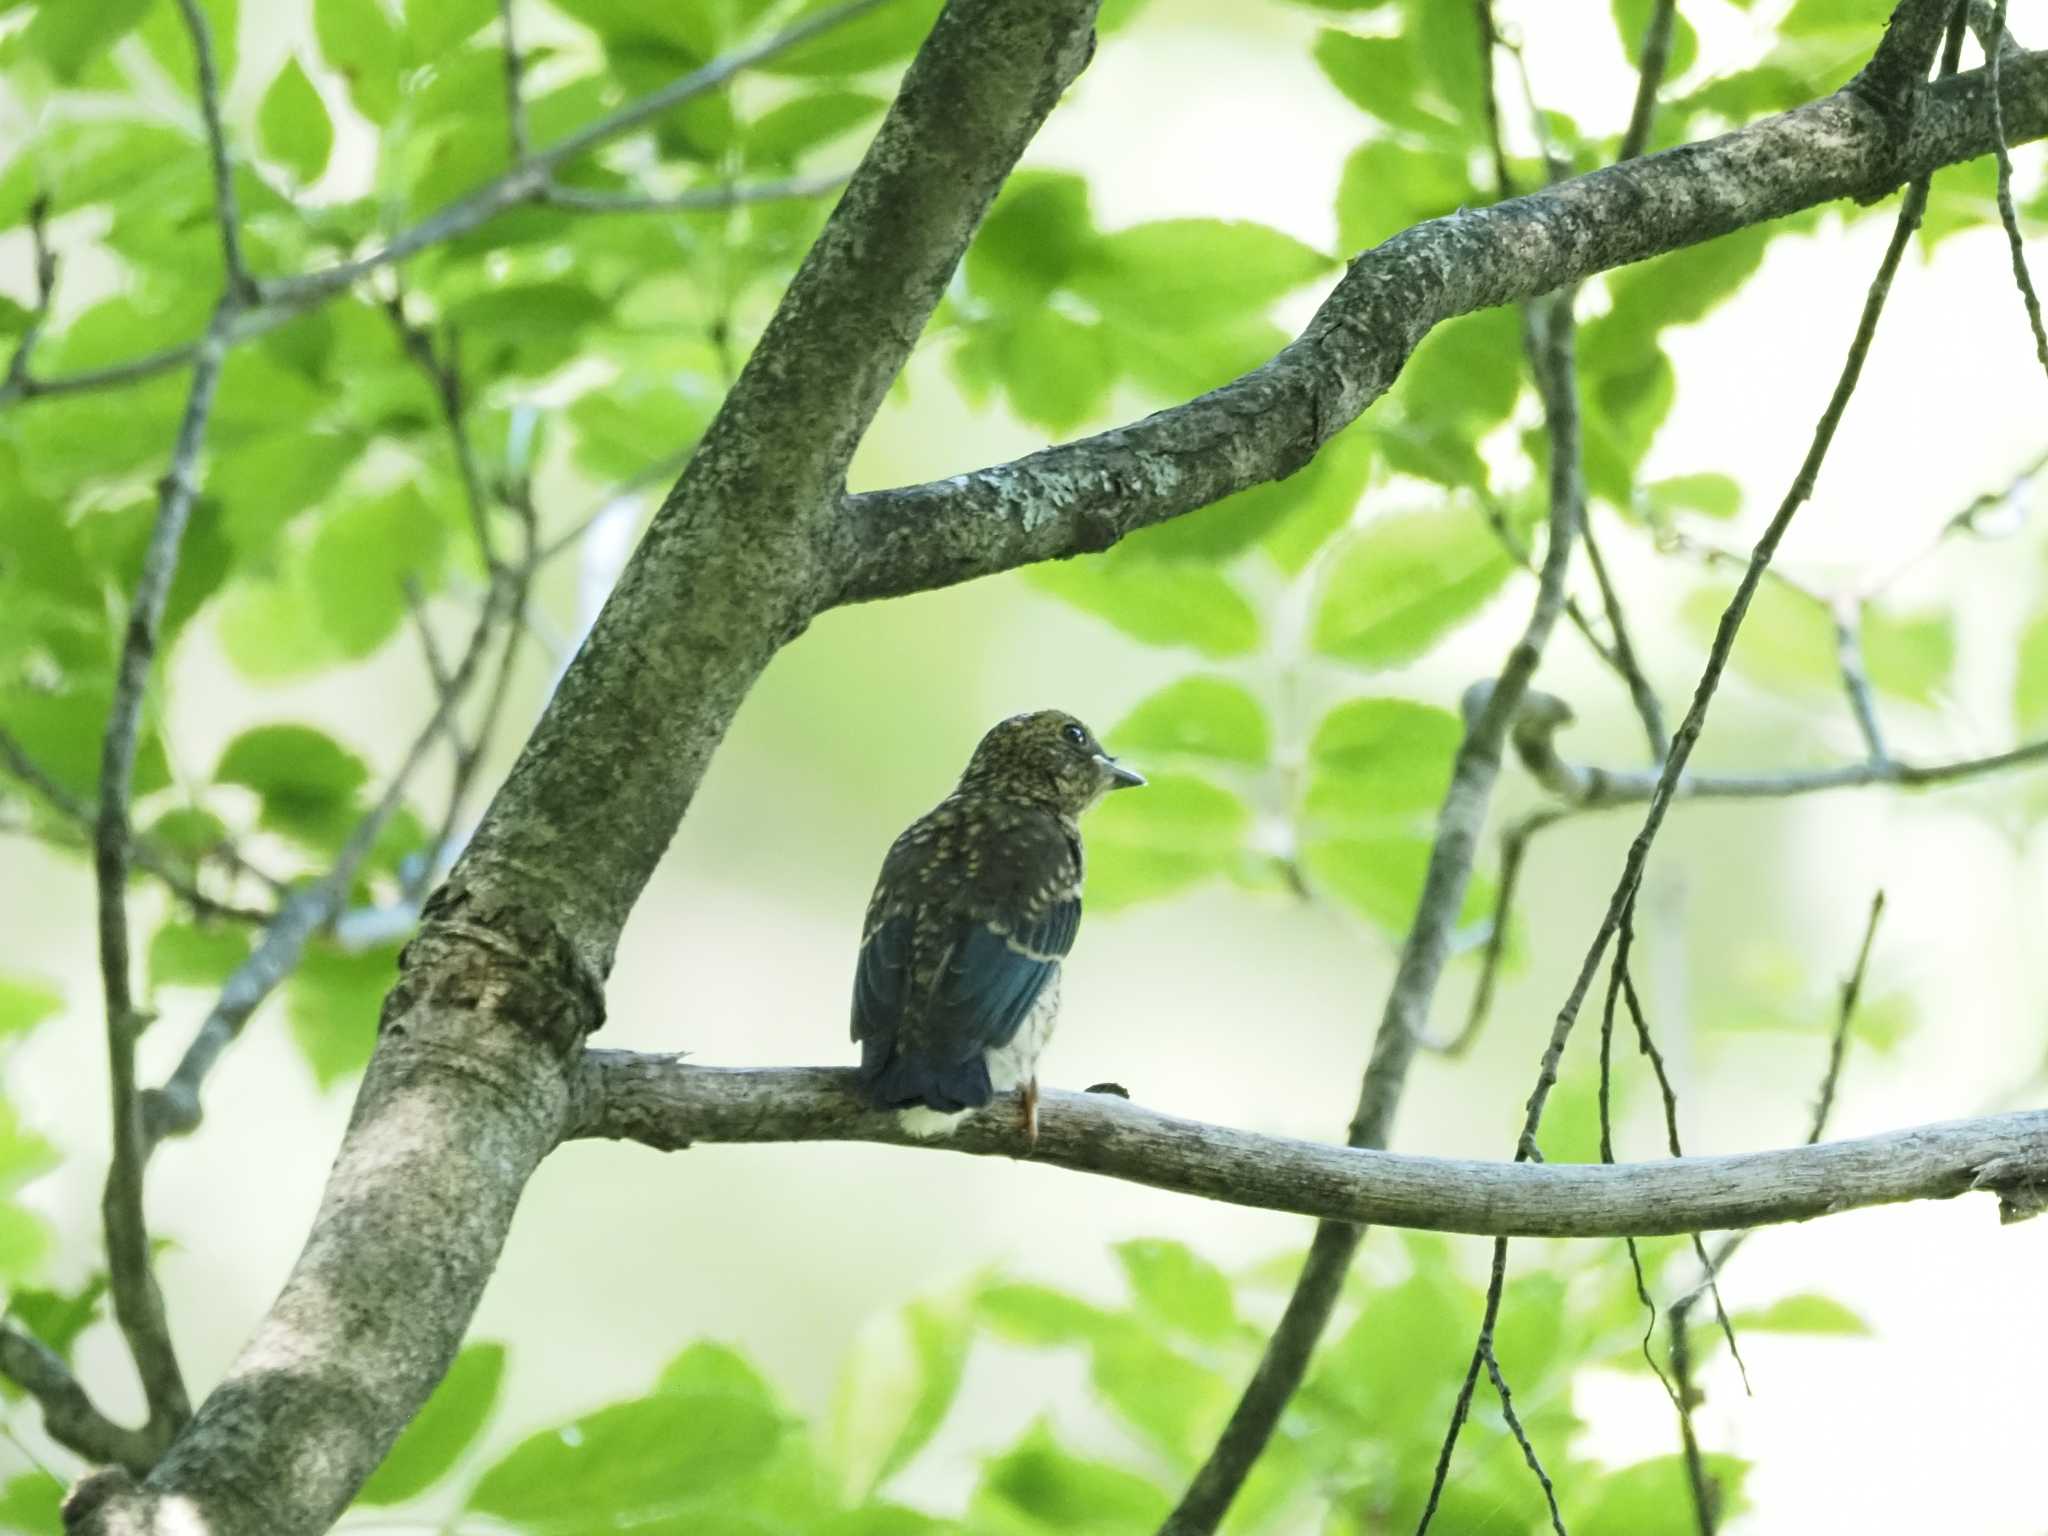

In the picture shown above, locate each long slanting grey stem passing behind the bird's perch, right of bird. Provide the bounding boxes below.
[1159,288,1581,1536]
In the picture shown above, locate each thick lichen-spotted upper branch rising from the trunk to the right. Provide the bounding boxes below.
[840,53,2048,602]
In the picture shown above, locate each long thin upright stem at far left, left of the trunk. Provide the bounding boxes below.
[92,309,236,1444]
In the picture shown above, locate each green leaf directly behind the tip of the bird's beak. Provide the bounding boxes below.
[1087,774,1251,911]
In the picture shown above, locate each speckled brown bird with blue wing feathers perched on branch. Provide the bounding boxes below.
[854,709,1145,1145]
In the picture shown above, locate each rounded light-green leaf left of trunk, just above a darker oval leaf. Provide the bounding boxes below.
[305,481,446,657]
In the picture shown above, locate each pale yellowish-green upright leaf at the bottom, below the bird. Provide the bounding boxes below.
[831,1298,973,1499]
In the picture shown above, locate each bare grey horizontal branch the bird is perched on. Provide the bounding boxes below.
[565,1073,2048,1237]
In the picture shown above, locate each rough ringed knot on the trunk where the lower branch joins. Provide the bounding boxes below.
[377,881,604,1059]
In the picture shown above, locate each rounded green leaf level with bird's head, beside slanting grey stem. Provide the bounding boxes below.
[1303,698,1464,827]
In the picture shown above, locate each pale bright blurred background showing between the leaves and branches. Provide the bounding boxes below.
[0,0,2048,1536]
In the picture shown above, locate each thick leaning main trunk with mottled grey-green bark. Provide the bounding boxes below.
[70,12,1094,1536]
